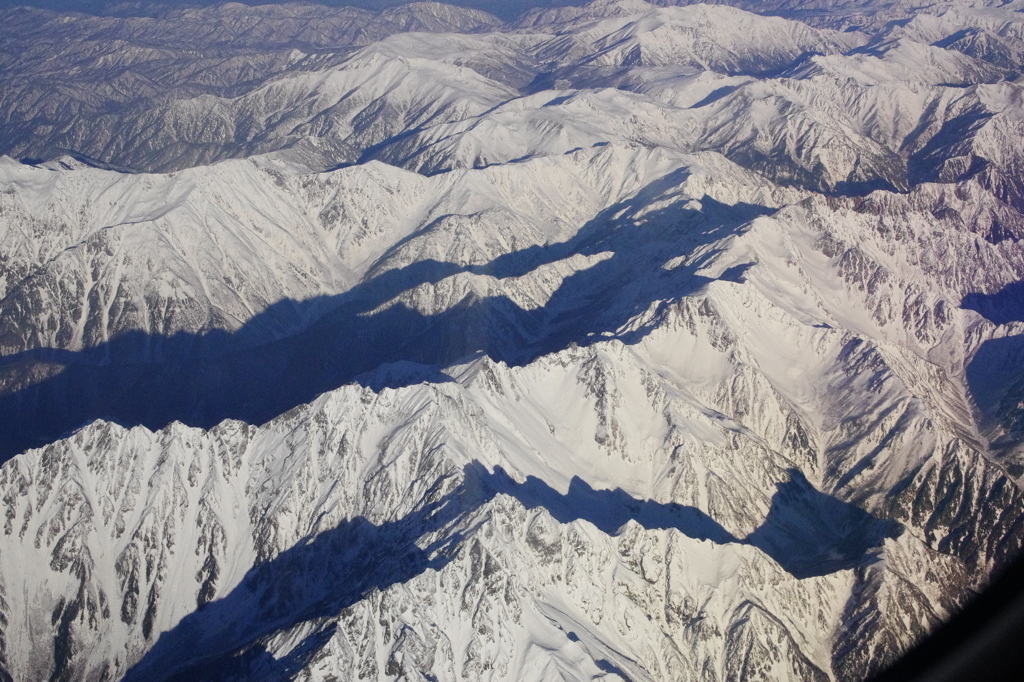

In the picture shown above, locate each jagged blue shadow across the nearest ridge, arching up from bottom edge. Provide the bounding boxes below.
[124,462,902,682]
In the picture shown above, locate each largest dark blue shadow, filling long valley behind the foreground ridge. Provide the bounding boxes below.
[0,166,770,462]
